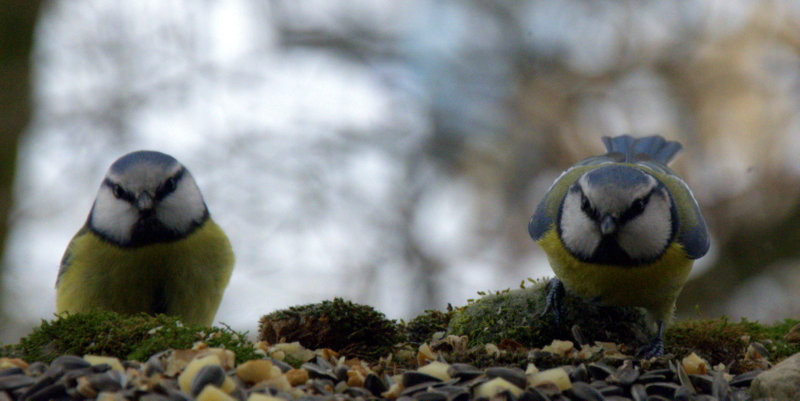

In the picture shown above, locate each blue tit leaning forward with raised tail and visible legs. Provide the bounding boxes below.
[528,135,709,357]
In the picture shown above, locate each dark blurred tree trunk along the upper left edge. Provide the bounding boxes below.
[0,0,40,311]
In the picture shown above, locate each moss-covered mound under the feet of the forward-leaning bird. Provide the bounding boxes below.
[448,281,654,347]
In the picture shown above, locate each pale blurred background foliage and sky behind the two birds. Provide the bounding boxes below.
[0,0,800,341]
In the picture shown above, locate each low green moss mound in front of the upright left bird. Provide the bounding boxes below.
[0,312,258,363]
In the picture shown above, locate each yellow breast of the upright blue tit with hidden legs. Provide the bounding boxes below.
[56,219,234,325]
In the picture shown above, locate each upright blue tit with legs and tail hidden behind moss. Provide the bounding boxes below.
[56,151,234,325]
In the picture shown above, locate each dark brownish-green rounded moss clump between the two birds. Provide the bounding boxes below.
[258,298,402,360]
